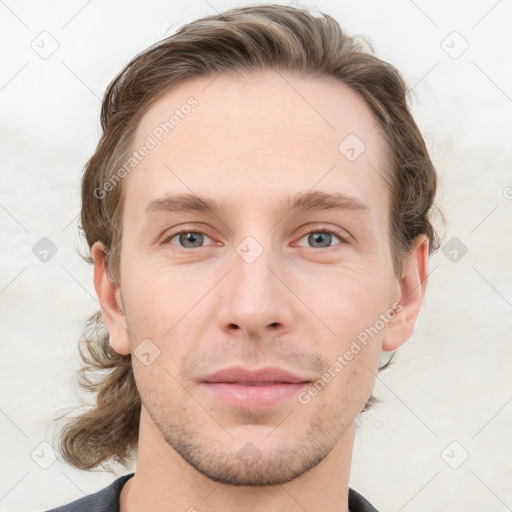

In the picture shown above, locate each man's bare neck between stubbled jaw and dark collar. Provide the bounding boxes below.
[120,407,355,512]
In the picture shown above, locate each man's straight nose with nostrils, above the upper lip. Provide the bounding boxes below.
[217,241,293,339]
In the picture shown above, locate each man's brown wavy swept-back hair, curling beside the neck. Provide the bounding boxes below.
[51,5,439,470]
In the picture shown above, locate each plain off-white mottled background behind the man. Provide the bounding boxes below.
[0,0,512,512]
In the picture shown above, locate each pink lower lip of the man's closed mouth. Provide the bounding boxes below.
[201,382,310,409]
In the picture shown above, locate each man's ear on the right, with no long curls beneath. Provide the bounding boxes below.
[382,235,429,352]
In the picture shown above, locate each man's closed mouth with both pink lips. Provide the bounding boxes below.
[200,367,312,409]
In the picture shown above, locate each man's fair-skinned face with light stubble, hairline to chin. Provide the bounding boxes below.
[114,73,400,485]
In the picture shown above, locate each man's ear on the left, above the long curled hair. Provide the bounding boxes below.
[91,242,130,355]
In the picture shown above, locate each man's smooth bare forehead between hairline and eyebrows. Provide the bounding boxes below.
[124,72,387,222]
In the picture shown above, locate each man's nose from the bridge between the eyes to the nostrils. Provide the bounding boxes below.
[218,236,291,335]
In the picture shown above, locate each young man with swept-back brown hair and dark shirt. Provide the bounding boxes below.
[47,5,438,512]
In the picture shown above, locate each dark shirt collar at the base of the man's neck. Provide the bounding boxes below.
[47,473,378,512]
